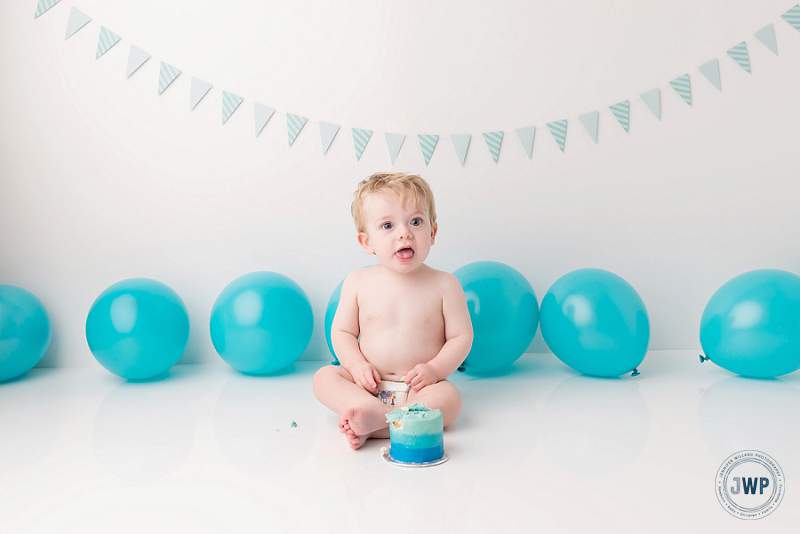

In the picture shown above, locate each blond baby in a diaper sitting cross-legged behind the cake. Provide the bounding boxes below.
[314,173,472,449]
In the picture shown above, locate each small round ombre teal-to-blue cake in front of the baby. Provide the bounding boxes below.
[386,403,444,464]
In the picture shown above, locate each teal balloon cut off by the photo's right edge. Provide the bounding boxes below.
[700,269,800,378]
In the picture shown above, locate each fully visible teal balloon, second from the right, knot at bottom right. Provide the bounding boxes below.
[541,269,650,377]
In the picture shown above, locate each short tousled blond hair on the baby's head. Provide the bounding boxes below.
[350,172,436,233]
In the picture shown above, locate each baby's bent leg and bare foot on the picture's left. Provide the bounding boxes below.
[313,365,393,449]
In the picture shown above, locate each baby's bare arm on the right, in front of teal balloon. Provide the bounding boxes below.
[405,273,472,391]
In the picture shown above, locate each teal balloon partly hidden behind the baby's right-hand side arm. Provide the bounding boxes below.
[453,261,539,373]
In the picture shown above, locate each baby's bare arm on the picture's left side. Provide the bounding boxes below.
[331,271,381,393]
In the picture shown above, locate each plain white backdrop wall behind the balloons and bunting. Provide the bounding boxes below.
[0,0,800,366]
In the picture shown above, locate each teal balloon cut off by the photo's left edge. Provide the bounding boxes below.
[0,285,50,382]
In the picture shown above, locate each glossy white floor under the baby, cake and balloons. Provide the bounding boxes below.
[0,351,800,533]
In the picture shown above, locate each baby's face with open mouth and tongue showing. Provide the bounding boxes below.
[358,191,437,273]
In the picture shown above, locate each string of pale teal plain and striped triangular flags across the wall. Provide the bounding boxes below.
[34,0,800,167]
